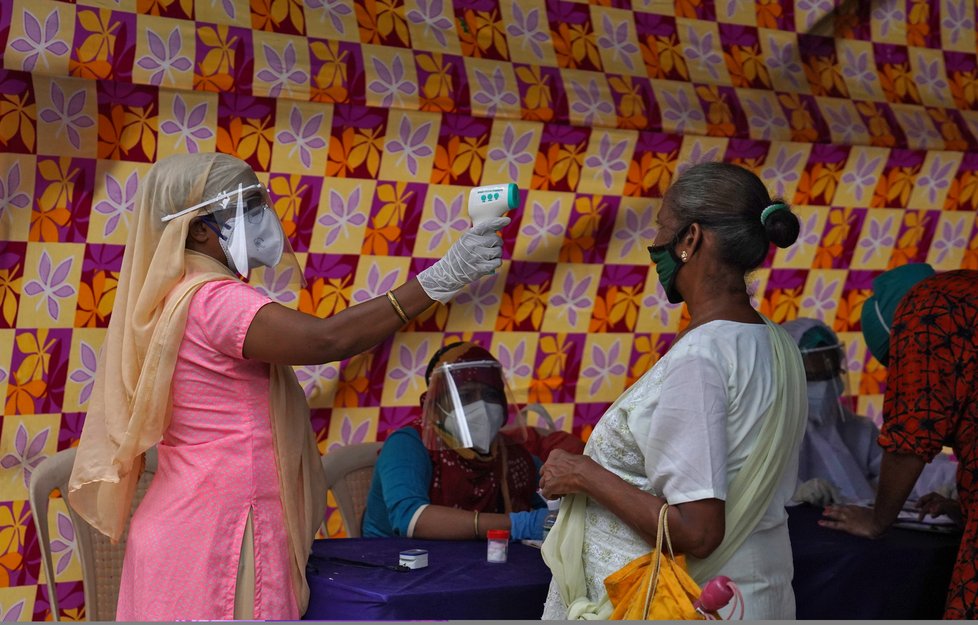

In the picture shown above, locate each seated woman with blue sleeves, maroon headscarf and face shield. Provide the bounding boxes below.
[362,343,547,540]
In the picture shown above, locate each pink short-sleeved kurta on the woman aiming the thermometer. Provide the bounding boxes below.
[116,280,300,620]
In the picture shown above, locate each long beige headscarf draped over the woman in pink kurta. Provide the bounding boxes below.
[68,154,326,613]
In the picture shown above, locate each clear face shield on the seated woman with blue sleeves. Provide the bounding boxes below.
[421,360,525,455]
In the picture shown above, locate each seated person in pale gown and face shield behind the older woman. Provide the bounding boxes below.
[782,318,957,510]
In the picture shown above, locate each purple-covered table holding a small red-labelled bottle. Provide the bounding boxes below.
[303,538,550,621]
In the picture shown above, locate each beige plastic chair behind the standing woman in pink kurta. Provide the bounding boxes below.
[29,447,156,621]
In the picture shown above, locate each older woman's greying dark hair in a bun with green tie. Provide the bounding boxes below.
[663,163,801,272]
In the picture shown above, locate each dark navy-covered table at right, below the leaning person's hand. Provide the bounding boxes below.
[788,505,961,620]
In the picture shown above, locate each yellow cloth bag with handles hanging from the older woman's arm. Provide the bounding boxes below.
[604,504,706,621]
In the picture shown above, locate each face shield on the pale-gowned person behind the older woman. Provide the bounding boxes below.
[801,343,852,424]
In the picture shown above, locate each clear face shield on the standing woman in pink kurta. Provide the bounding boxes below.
[163,183,303,286]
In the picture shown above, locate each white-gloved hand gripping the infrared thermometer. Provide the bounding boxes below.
[418,217,509,303]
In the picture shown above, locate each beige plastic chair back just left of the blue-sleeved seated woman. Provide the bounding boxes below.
[323,442,384,538]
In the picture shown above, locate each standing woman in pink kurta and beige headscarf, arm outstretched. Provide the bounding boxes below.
[68,154,509,620]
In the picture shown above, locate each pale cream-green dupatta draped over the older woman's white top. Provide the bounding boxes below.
[542,318,808,620]
